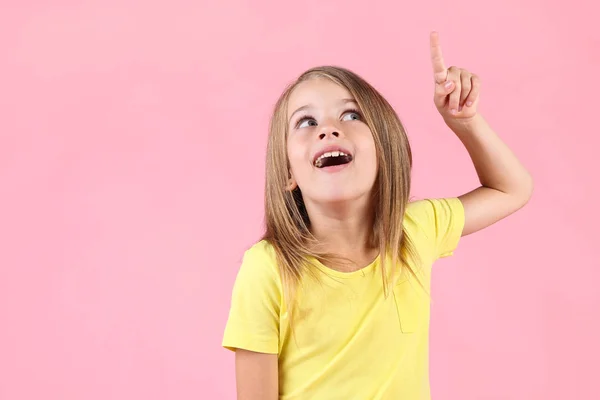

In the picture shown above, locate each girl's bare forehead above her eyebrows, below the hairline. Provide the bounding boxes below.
[287,78,353,117]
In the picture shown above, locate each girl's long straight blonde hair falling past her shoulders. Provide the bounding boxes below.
[263,66,417,311]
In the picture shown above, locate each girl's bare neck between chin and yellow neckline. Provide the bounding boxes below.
[306,196,378,270]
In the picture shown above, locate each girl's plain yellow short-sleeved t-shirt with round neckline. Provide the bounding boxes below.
[223,198,464,400]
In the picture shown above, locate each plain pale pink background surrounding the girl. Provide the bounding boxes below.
[0,0,600,400]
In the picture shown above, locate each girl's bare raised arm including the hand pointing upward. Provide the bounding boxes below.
[430,32,533,236]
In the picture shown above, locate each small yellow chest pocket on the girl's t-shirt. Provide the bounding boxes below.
[394,279,429,333]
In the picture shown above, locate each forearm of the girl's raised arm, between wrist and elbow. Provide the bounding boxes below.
[449,114,533,202]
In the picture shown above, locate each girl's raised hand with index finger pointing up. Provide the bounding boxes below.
[430,32,480,124]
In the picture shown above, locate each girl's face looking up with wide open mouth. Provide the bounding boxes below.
[287,78,377,206]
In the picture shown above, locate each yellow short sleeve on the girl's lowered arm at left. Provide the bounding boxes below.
[222,242,282,354]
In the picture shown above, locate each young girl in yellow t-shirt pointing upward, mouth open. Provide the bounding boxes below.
[223,32,532,400]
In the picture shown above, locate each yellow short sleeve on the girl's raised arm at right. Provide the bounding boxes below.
[407,197,465,259]
